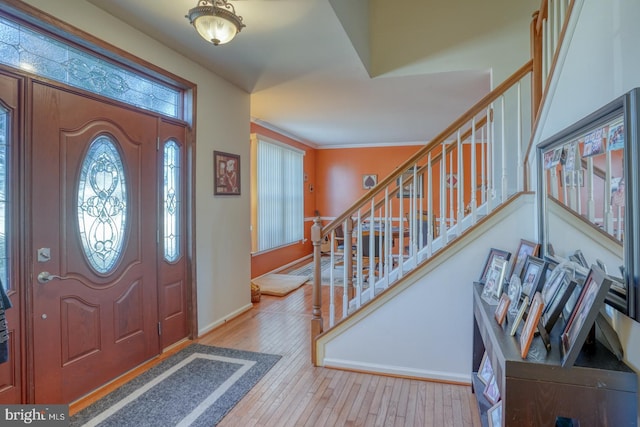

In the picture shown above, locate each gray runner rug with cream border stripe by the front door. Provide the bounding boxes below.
[71,344,281,427]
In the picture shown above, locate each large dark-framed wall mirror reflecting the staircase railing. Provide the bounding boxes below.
[536,88,640,322]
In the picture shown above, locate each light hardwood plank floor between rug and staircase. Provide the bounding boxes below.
[71,284,481,427]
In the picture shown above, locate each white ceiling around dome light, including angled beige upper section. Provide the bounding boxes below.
[87,0,540,148]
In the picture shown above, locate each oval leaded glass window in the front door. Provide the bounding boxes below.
[78,135,128,274]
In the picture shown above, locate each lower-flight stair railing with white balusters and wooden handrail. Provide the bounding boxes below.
[312,61,532,331]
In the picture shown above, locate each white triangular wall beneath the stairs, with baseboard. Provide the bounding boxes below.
[316,194,536,383]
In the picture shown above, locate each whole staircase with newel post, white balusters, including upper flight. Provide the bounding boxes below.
[311,0,573,370]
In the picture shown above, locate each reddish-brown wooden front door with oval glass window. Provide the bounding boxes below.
[29,82,160,404]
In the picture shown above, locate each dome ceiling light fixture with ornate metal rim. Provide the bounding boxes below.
[185,0,246,46]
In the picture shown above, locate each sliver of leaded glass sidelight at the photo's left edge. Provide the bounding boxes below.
[0,107,9,289]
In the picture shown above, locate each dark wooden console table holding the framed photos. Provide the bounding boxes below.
[472,284,638,427]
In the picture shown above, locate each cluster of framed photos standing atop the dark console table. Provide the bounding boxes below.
[479,239,615,366]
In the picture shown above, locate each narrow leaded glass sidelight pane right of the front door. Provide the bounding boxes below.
[163,140,181,262]
